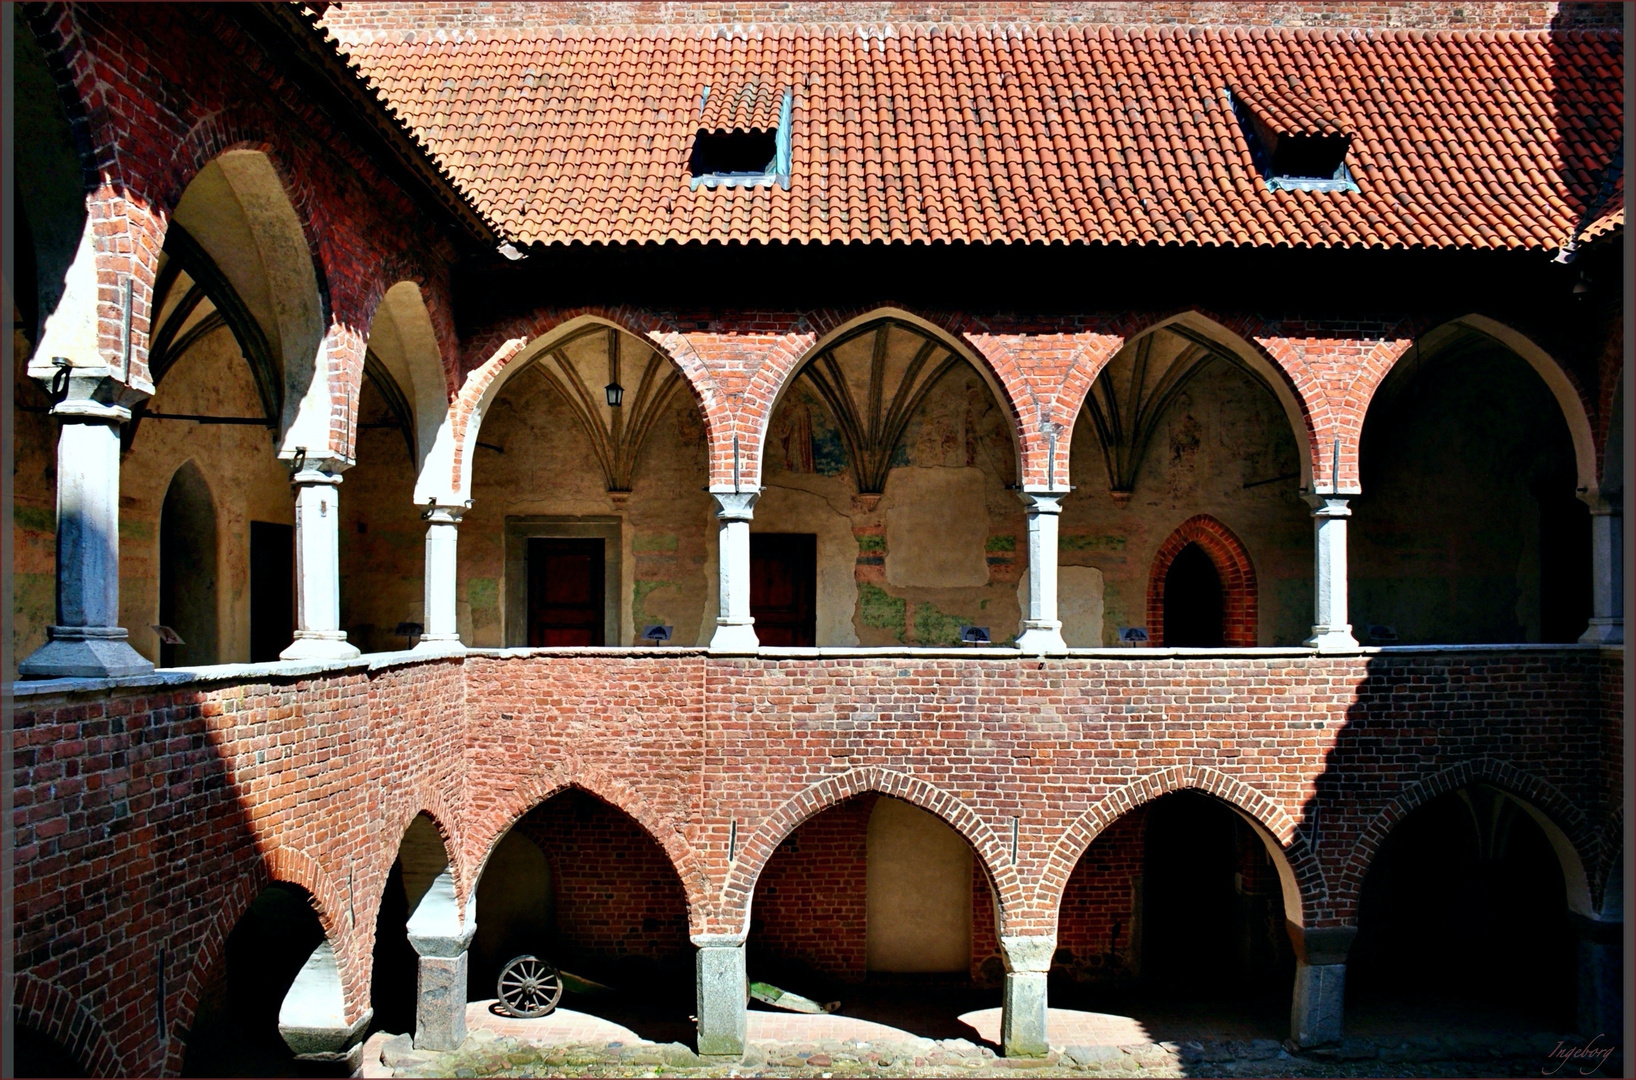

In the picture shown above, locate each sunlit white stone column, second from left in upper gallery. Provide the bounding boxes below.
[278,461,358,659]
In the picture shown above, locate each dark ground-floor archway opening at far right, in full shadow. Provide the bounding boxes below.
[1346,784,1593,1034]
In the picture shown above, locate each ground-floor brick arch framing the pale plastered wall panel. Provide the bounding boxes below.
[720,766,1026,933]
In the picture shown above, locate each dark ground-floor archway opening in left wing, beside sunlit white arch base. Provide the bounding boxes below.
[182,882,324,1077]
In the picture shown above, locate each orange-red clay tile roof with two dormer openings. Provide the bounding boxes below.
[341,26,1623,249]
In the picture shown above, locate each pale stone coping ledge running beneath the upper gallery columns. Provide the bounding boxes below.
[9,641,1625,700]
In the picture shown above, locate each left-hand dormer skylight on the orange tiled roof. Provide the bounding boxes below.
[687,80,795,191]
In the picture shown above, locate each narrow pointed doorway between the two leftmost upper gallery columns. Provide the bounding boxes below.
[159,461,219,668]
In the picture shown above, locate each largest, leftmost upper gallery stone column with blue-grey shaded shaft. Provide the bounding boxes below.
[18,368,154,679]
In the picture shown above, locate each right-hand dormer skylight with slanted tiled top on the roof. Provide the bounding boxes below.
[1227,87,1358,191]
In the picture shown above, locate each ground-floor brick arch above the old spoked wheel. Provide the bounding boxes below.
[458,763,710,933]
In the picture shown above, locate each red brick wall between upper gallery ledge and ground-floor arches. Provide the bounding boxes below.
[15,648,1625,1075]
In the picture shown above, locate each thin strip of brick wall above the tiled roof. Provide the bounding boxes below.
[324,0,1620,43]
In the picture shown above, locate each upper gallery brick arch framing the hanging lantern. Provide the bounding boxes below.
[435,308,733,502]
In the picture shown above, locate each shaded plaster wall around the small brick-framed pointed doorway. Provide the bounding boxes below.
[1057,343,1312,646]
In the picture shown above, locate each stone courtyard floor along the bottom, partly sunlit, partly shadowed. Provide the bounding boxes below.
[362,990,1615,1077]
